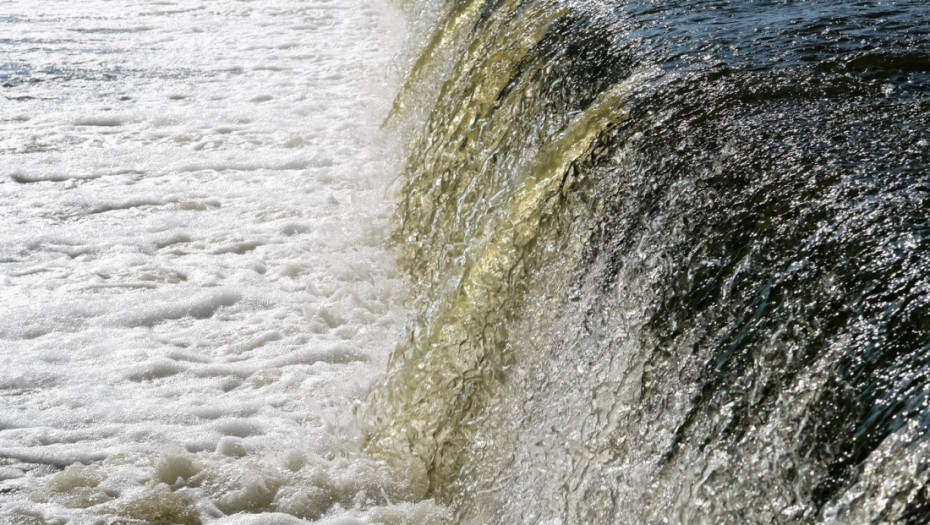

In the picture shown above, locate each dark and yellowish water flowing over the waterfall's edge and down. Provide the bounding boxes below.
[367,0,930,524]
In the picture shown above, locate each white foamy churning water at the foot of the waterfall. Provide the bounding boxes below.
[0,0,450,525]
